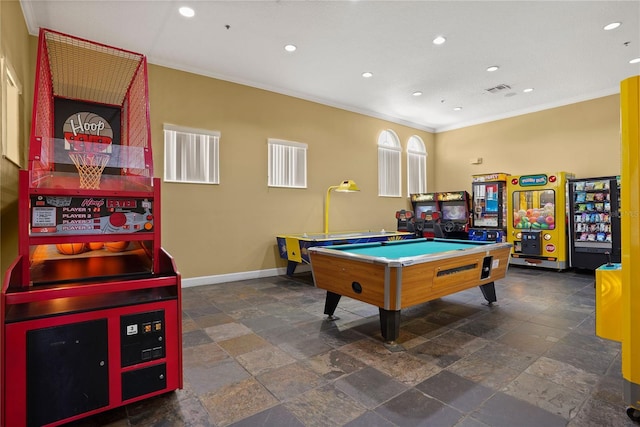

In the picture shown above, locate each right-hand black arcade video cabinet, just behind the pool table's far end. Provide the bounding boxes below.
[438,191,471,240]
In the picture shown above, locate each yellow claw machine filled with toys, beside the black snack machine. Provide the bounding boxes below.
[507,172,573,270]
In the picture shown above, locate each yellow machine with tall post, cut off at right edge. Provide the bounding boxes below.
[596,76,640,422]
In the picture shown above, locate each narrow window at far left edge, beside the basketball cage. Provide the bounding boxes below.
[0,58,22,166]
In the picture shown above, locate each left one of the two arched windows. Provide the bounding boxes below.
[378,130,402,197]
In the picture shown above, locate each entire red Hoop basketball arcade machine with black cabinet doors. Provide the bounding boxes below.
[0,29,182,426]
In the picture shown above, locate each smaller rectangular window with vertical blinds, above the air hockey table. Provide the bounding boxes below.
[267,138,307,188]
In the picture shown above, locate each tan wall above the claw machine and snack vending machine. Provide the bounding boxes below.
[431,95,620,191]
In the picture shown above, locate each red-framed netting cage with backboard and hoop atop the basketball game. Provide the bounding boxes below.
[29,29,153,190]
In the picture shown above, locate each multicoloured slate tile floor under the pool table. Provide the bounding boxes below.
[71,266,636,427]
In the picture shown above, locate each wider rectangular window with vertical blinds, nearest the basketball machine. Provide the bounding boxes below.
[164,124,220,184]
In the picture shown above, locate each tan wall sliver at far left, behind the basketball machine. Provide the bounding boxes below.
[0,0,33,276]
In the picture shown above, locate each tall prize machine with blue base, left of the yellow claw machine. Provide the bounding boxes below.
[469,172,508,242]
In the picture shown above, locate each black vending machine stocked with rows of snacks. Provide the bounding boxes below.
[568,176,620,270]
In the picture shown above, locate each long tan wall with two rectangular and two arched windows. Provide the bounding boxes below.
[149,65,434,277]
